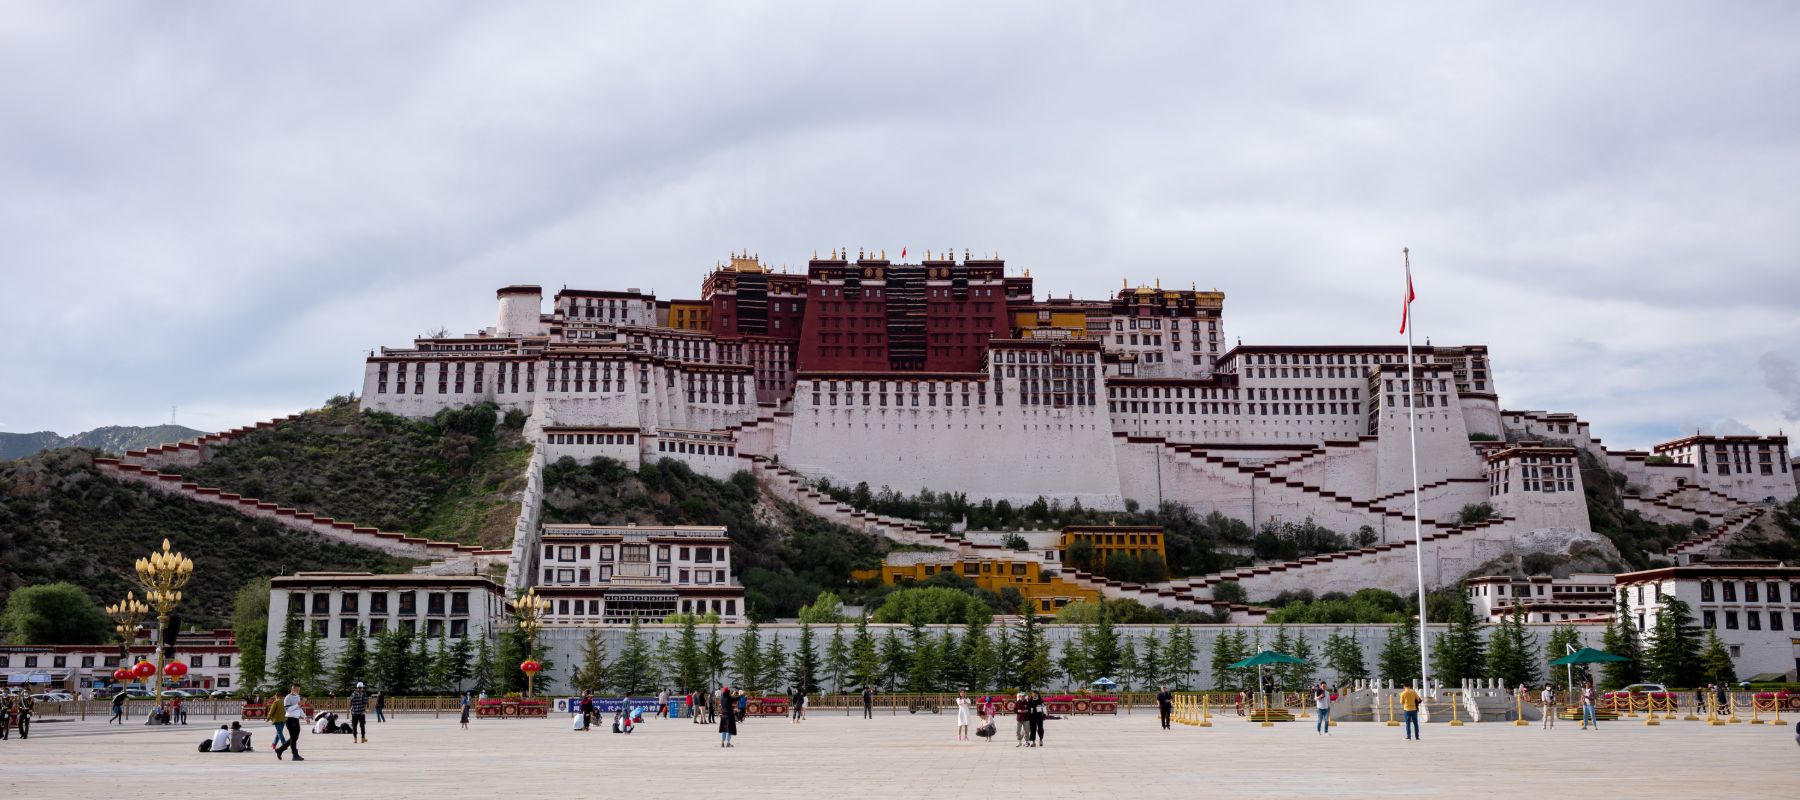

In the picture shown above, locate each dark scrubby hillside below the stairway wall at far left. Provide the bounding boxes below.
[0,449,412,625]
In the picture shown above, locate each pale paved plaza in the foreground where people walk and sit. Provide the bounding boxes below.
[0,710,1800,800]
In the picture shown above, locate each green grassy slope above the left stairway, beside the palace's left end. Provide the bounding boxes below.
[182,398,531,548]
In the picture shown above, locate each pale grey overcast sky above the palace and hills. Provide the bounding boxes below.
[0,0,1800,447]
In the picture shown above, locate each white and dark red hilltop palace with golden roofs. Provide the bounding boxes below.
[343,252,1795,600]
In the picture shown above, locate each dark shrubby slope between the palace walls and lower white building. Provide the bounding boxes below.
[544,458,889,620]
